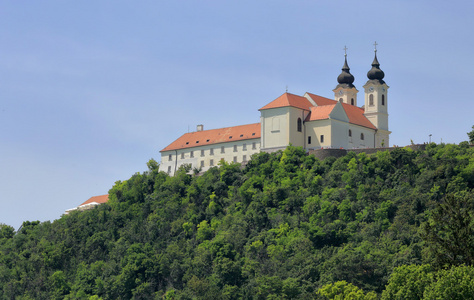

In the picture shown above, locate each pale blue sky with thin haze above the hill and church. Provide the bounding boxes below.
[0,0,474,228]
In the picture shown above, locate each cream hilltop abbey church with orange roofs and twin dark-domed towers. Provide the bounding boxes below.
[160,44,391,175]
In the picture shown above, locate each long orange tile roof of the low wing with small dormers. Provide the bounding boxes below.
[160,123,260,152]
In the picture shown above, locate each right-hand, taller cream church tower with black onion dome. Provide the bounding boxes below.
[364,42,391,147]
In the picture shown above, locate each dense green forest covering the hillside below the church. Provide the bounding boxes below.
[0,142,474,299]
